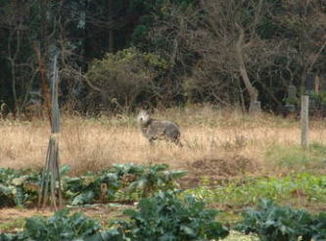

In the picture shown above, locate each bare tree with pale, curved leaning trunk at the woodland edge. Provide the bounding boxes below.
[194,0,277,113]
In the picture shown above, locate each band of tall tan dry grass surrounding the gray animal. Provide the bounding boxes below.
[0,106,326,175]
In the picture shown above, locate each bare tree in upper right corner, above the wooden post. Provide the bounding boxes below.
[278,0,326,90]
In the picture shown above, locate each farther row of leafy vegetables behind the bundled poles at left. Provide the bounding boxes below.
[0,164,186,207]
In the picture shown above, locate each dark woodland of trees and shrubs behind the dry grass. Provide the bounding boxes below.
[0,0,326,115]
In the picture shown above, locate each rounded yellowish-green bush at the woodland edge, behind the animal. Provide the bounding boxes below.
[86,48,168,110]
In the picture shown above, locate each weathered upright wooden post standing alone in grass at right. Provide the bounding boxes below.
[300,95,309,149]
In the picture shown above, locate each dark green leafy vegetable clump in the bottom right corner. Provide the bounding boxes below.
[237,200,326,241]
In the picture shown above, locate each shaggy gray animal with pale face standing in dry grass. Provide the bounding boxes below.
[137,111,181,146]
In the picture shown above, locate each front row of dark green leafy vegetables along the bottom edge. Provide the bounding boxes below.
[0,194,326,241]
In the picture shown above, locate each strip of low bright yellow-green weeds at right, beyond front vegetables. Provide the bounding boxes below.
[185,173,326,207]
